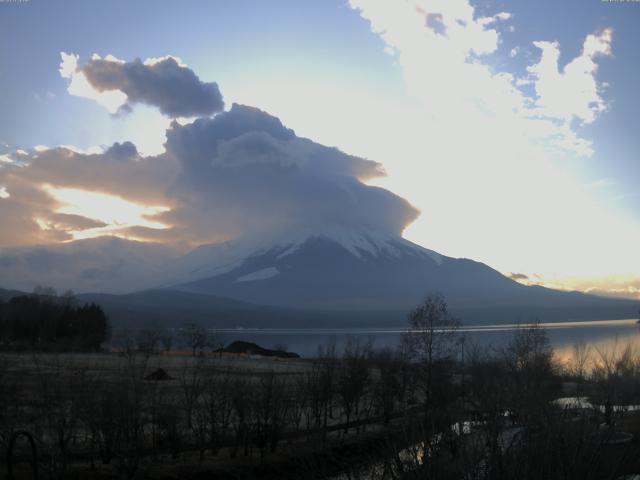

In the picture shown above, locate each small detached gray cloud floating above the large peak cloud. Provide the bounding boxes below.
[80,57,224,117]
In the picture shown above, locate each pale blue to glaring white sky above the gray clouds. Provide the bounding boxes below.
[0,0,640,294]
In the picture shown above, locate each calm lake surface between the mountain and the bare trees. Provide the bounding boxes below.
[216,319,640,357]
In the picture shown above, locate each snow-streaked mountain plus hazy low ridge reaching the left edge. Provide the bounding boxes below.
[0,227,637,327]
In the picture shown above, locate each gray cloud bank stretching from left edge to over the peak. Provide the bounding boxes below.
[0,105,418,246]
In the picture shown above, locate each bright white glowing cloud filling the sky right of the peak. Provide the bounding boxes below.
[344,0,640,286]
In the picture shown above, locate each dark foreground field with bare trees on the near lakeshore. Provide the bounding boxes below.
[6,320,640,480]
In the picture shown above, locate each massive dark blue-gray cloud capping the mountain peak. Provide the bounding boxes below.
[164,105,418,237]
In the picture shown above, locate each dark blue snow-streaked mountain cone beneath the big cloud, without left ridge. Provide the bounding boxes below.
[176,231,634,315]
